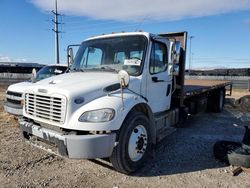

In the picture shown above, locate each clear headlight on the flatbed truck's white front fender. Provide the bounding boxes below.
[79,108,115,122]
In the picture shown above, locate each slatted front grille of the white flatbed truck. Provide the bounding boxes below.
[25,93,66,124]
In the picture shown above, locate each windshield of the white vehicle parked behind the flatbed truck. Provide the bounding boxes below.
[35,66,67,81]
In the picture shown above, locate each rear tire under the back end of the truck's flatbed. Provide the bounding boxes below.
[208,89,225,113]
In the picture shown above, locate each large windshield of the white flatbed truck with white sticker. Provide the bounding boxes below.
[70,35,147,76]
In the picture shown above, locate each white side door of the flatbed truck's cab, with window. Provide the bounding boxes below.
[147,40,172,113]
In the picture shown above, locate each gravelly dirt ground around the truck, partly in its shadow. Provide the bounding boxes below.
[0,89,250,188]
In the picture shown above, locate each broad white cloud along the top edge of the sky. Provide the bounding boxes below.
[29,0,250,21]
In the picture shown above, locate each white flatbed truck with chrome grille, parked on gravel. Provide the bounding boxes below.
[19,32,230,173]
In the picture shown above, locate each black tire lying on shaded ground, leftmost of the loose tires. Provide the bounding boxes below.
[213,140,241,164]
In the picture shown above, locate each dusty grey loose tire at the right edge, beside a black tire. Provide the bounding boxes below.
[227,147,250,168]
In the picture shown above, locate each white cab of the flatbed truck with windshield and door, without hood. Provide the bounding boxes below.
[71,33,176,112]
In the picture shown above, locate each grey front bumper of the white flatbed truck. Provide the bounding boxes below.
[19,119,116,159]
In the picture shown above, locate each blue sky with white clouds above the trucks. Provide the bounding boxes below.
[0,0,250,68]
